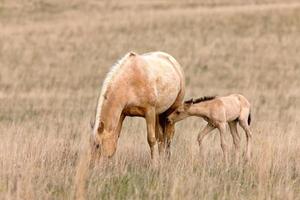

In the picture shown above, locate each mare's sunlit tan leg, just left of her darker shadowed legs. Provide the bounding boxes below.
[145,107,156,159]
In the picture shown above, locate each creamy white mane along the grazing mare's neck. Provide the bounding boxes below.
[93,52,132,135]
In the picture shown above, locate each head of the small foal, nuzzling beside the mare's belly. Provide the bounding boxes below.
[168,99,193,123]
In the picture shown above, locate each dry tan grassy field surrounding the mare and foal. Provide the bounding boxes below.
[0,0,300,199]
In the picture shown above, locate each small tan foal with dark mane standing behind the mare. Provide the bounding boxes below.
[167,94,252,164]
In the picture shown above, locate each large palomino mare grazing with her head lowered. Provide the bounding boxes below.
[91,52,185,161]
